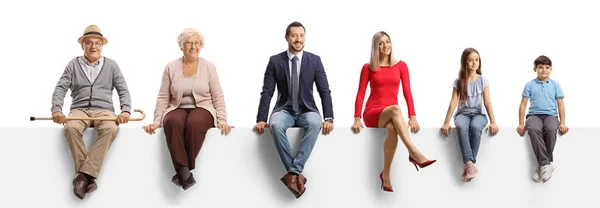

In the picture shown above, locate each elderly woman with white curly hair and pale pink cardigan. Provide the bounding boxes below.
[143,28,233,190]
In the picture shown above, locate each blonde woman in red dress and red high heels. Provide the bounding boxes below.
[352,31,436,192]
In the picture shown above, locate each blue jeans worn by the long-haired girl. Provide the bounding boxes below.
[454,114,488,163]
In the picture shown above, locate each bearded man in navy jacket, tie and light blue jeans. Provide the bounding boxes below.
[254,22,333,198]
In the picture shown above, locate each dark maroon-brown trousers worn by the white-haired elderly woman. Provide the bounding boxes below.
[163,108,215,171]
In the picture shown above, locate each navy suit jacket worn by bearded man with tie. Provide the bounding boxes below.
[256,51,333,123]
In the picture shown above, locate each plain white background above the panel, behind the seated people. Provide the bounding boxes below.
[0,0,600,128]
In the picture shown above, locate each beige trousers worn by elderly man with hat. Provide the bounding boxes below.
[65,109,118,178]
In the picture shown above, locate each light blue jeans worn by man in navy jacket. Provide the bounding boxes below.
[269,109,322,174]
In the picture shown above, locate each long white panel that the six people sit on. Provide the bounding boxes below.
[0,127,600,207]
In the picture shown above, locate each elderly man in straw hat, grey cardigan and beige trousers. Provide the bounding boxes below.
[51,25,131,199]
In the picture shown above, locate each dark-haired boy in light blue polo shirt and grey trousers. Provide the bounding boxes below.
[517,55,569,183]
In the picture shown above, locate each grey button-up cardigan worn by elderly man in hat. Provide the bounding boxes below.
[51,57,131,113]
